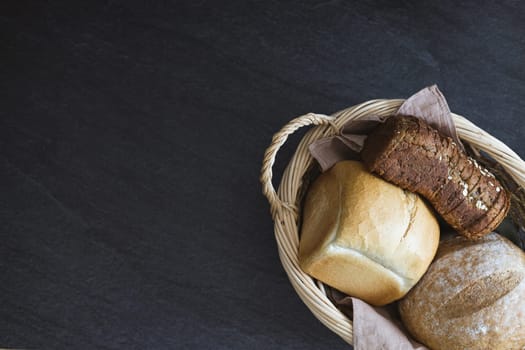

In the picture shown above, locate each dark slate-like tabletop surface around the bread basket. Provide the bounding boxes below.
[0,1,525,350]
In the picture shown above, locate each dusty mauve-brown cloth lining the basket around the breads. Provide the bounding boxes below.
[309,85,464,350]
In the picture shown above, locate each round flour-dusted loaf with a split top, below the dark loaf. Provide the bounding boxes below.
[399,233,525,350]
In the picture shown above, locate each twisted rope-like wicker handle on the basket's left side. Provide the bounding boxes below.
[260,113,337,215]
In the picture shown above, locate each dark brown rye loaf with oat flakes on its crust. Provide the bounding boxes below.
[361,116,510,239]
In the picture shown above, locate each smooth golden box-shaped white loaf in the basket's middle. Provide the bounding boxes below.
[299,161,439,305]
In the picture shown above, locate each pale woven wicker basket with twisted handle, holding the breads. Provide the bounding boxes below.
[261,99,525,344]
